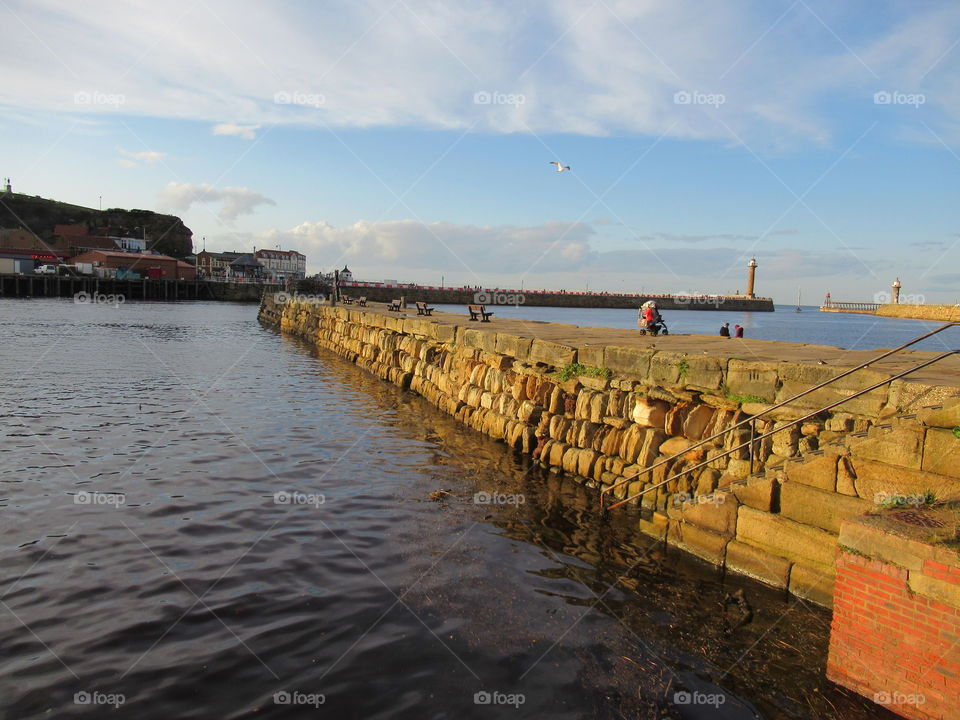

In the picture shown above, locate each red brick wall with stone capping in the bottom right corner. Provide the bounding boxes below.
[827,516,960,720]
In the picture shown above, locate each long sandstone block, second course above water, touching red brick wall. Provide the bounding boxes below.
[737,505,837,567]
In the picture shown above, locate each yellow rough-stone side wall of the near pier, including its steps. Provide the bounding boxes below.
[261,296,960,605]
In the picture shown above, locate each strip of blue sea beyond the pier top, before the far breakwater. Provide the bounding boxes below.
[437,305,960,352]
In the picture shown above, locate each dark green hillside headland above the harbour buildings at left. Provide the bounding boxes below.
[0,193,193,258]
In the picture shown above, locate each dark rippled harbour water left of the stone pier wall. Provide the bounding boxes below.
[0,299,893,720]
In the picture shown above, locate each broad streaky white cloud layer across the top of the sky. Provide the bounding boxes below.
[0,0,960,146]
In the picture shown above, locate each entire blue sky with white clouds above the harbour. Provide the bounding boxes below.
[0,0,960,304]
